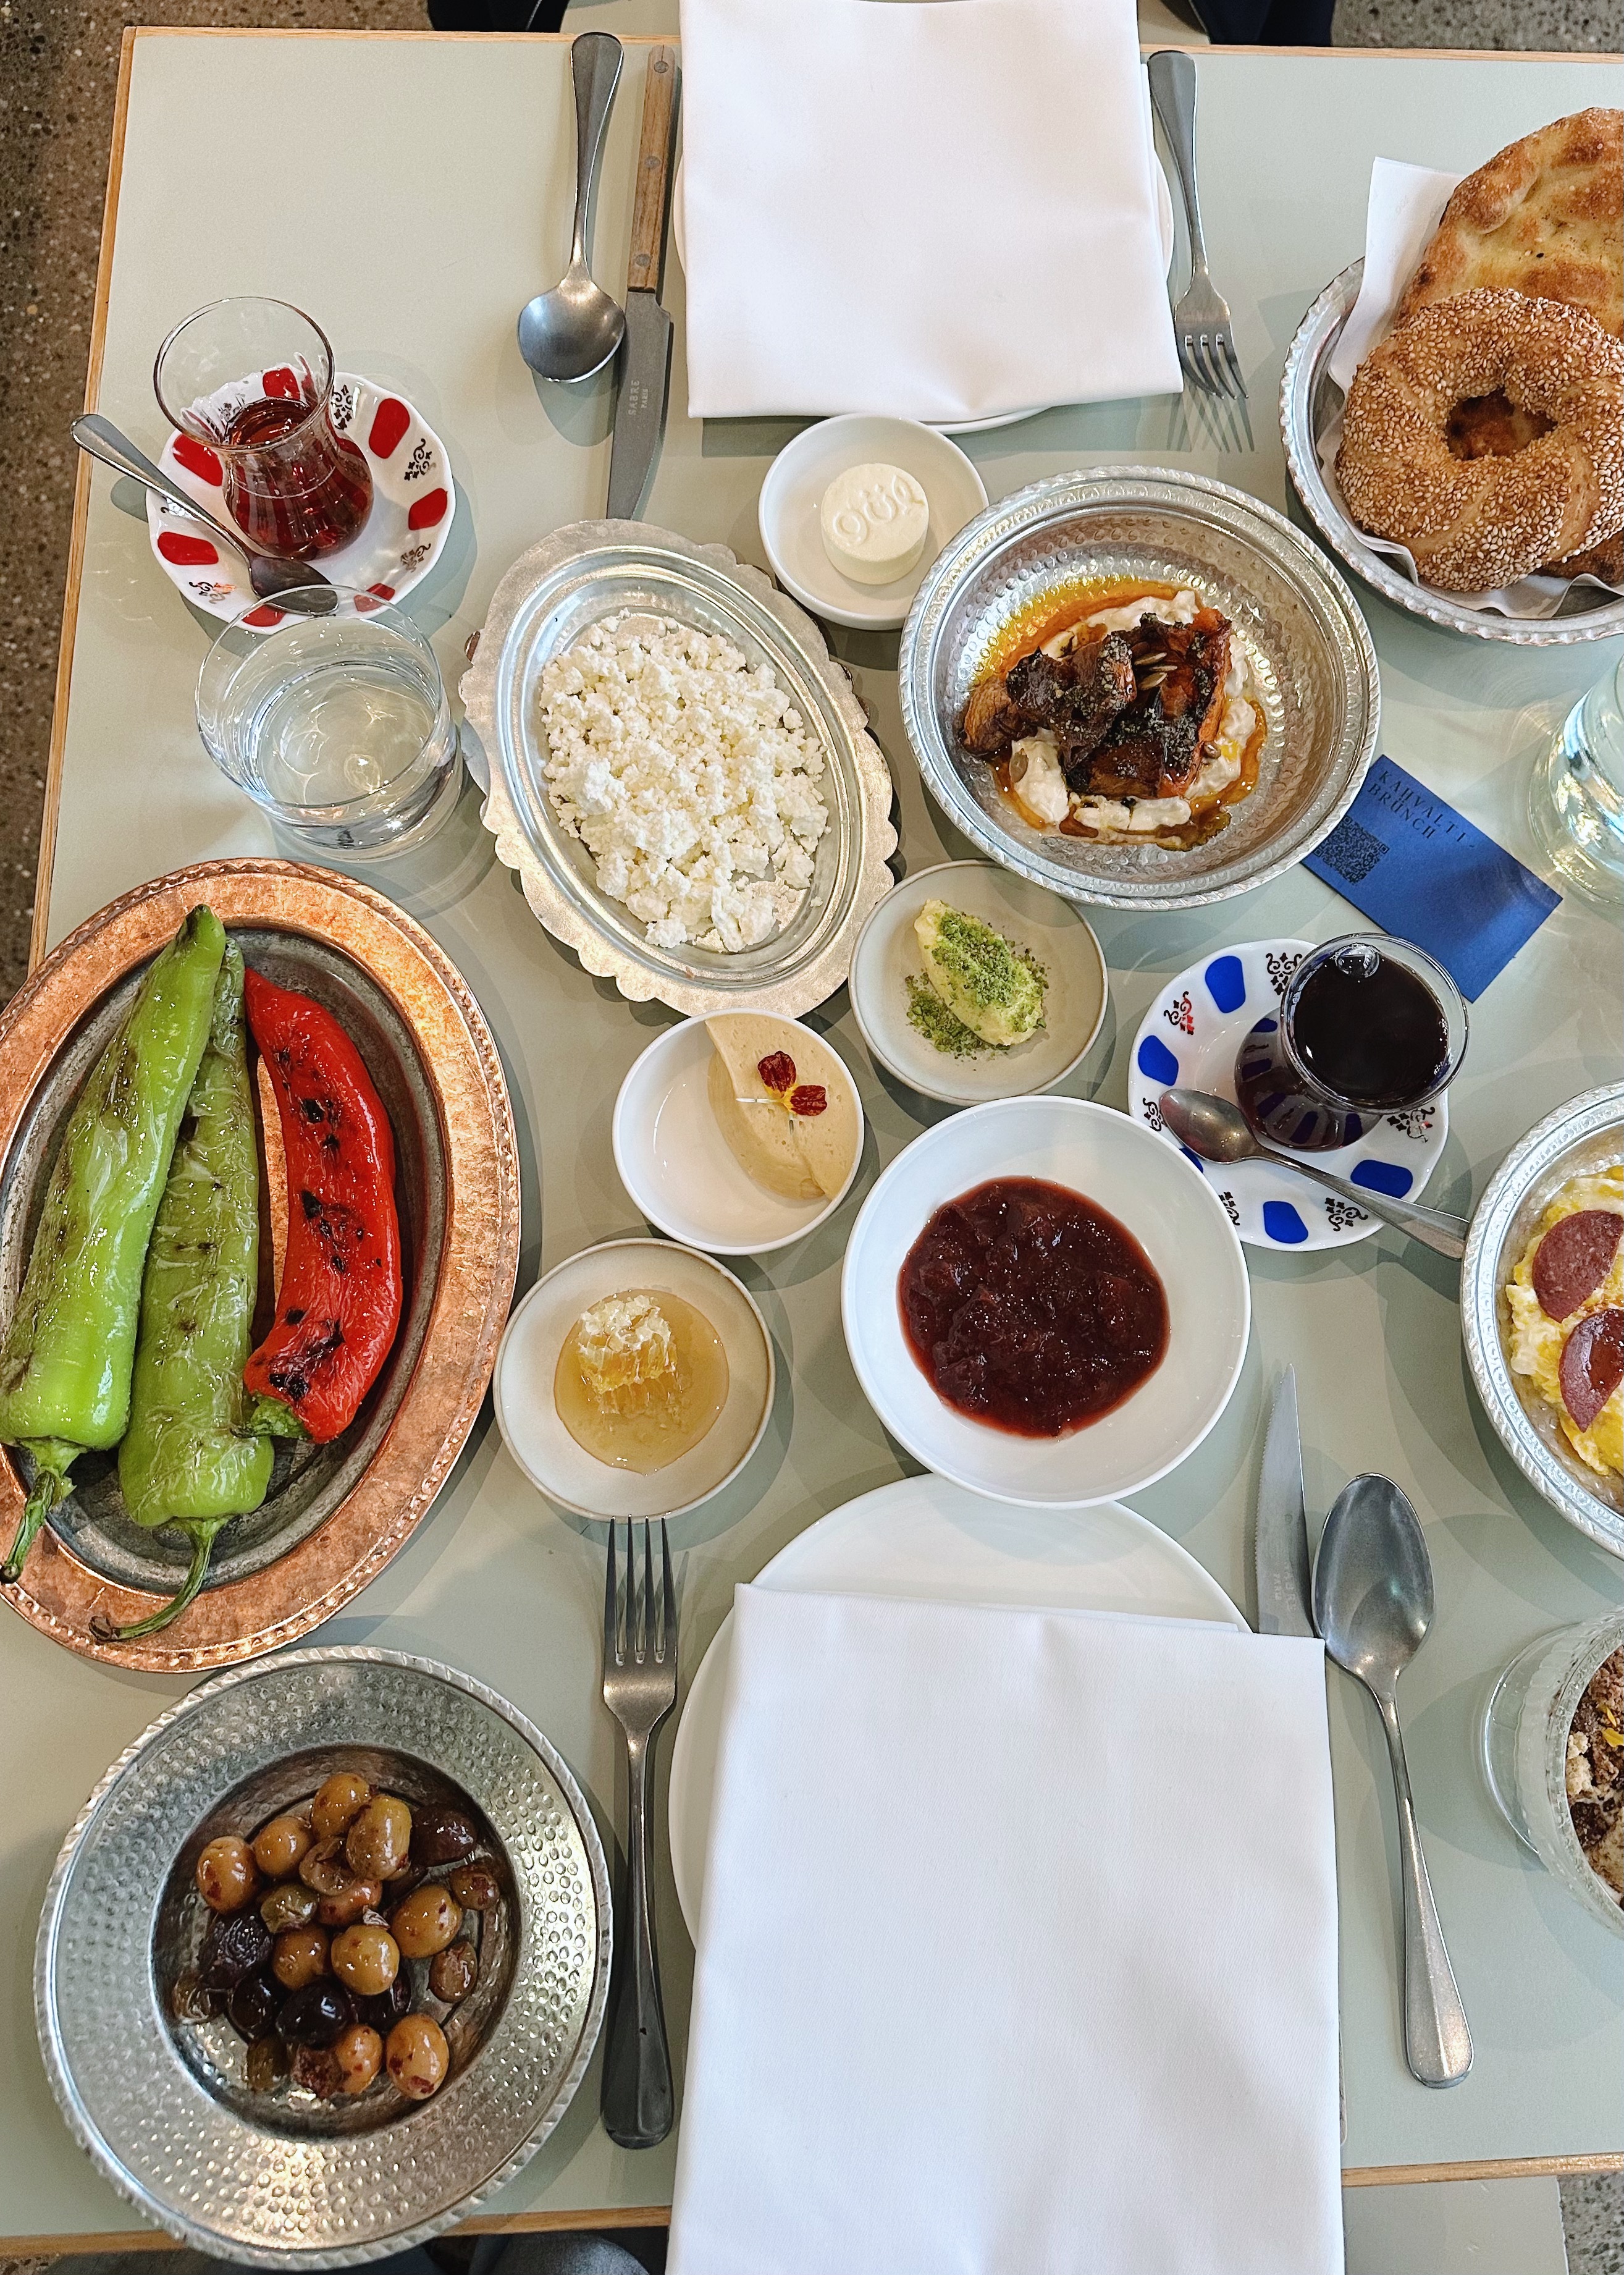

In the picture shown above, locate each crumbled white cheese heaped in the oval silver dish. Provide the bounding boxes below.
[539,617,828,953]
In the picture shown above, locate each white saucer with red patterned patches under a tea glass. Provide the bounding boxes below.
[146,371,457,633]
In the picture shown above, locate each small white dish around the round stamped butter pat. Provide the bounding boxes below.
[757,414,987,633]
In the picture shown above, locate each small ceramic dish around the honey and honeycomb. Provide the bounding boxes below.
[494,1240,773,1522]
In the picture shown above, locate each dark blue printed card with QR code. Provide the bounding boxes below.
[1303,758,1563,1003]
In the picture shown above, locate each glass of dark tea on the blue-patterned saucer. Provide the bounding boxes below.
[1235,933,1467,1154]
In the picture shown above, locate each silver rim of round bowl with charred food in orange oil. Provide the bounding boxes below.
[896,466,1381,910]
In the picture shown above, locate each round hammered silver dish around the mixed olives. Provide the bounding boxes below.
[34,1647,610,2268]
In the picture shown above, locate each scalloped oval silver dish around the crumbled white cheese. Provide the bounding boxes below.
[461,521,896,1017]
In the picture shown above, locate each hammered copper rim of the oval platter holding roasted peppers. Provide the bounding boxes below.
[0,860,519,1674]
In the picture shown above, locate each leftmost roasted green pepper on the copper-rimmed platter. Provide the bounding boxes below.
[0,908,225,1581]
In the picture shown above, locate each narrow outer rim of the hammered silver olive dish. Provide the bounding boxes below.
[34,1645,614,2268]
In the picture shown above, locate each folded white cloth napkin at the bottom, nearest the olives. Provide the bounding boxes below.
[671,1588,1342,2275]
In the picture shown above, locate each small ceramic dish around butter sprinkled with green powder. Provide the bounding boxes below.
[851,860,1108,1105]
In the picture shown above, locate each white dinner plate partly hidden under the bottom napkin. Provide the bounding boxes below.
[669,1477,1247,1938]
